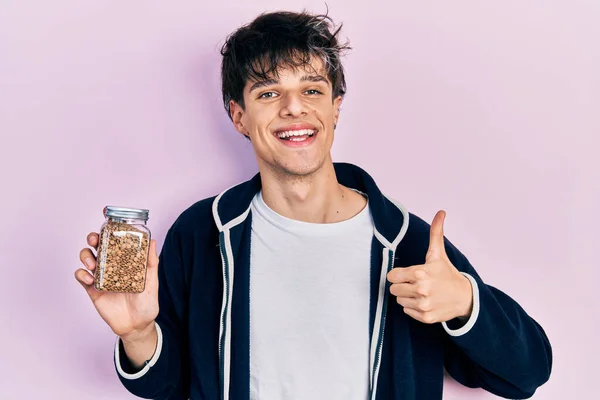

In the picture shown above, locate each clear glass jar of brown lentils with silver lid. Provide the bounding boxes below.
[94,206,150,293]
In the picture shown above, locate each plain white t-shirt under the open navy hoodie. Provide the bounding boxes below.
[250,192,373,400]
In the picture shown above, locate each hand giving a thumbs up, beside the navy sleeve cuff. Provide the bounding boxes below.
[387,211,473,324]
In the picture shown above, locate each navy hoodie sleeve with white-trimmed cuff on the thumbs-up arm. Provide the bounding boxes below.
[442,234,552,399]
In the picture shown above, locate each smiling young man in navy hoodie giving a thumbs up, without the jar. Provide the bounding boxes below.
[75,13,552,400]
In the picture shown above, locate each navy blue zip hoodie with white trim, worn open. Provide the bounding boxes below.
[115,163,552,400]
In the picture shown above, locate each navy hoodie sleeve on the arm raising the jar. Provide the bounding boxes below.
[115,227,189,400]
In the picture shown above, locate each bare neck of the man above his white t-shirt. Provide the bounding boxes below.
[261,162,366,223]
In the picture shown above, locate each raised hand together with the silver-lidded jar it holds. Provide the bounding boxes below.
[75,207,158,342]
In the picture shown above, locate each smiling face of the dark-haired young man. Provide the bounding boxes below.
[231,59,342,177]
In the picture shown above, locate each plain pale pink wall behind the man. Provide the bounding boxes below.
[0,0,600,400]
